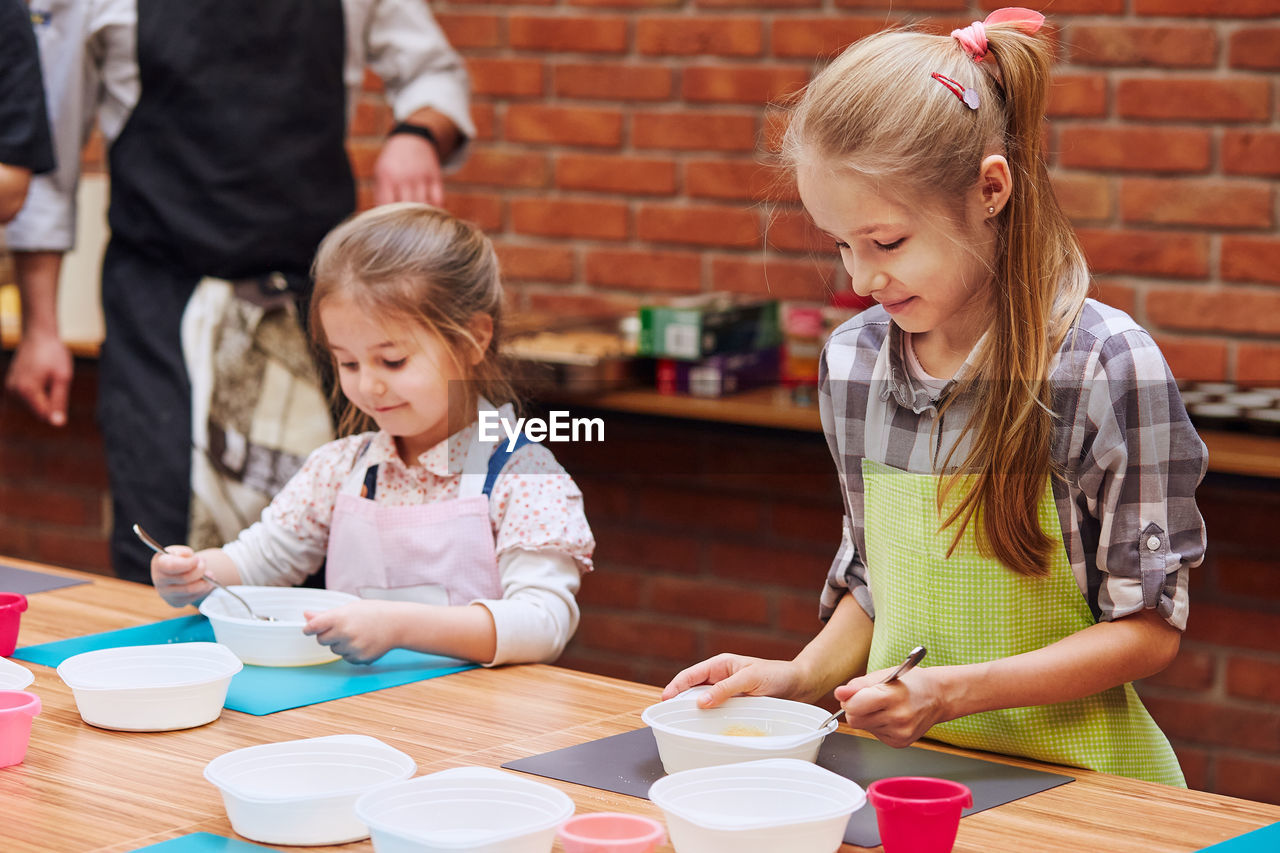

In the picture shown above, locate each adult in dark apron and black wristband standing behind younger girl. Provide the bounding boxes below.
[6,0,474,581]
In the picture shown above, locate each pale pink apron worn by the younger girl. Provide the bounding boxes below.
[325,406,529,605]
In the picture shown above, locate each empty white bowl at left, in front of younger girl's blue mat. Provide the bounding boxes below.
[58,643,243,731]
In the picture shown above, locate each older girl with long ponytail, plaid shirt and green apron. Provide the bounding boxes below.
[664,9,1207,785]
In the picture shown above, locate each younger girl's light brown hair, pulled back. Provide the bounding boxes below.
[310,202,515,434]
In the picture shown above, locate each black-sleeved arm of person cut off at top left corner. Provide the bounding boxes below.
[0,0,54,224]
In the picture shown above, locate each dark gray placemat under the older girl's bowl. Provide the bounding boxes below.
[503,729,1074,847]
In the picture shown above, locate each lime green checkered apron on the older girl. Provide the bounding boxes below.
[863,459,1187,788]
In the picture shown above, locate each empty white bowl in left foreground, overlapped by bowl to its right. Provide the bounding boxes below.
[205,735,417,845]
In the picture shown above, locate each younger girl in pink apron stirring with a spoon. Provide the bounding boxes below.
[151,202,595,663]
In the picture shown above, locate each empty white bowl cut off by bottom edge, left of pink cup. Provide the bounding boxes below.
[356,767,573,853]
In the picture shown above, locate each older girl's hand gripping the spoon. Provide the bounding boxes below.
[836,666,950,748]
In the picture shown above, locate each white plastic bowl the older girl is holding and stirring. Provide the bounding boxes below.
[640,690,840,774]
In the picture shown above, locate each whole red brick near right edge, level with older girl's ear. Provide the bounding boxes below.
[1120,178,1275,229]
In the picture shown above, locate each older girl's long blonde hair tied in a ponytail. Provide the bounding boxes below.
[782,24,1089,575]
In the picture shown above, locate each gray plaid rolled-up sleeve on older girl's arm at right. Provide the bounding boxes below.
[1080,330,1208,630]
